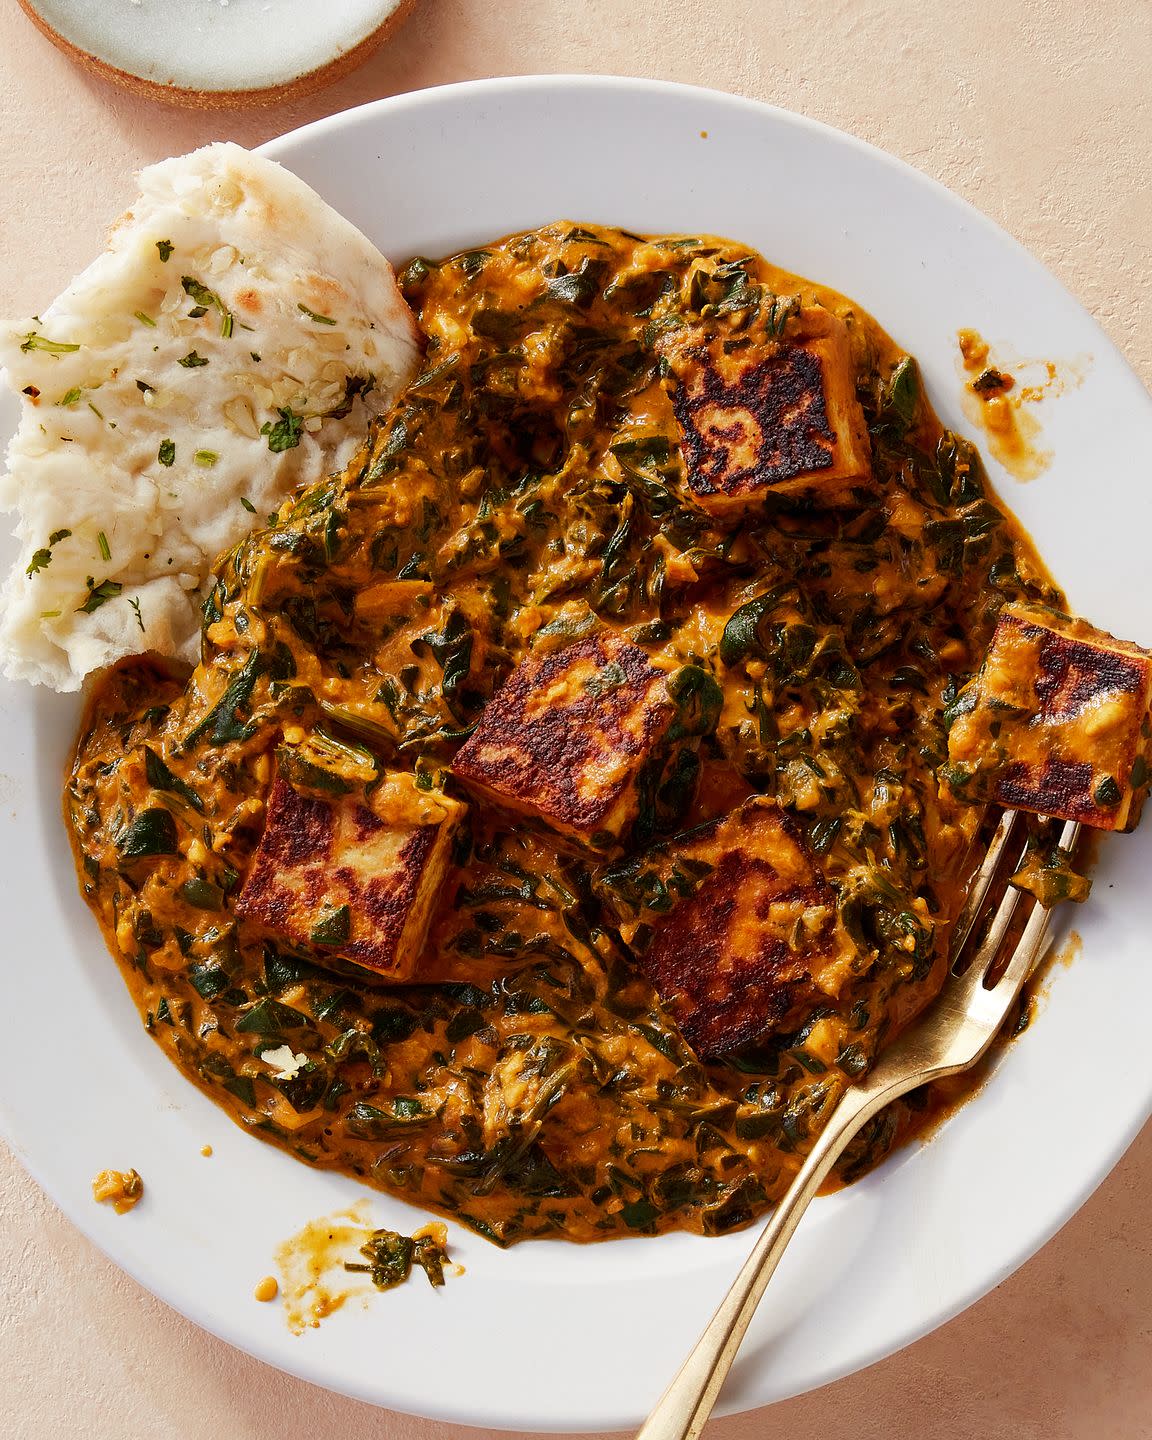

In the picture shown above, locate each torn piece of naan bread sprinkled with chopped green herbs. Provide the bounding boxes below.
[0,144,420,690]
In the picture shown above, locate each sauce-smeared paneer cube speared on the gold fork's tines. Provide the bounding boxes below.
[943,605,1152,829]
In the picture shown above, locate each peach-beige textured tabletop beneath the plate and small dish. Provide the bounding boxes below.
[0,0,1152,1440]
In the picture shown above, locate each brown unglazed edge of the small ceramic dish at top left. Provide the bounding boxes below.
[19,0,419,109]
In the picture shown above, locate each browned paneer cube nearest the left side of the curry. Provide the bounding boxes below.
[236,769,467,981]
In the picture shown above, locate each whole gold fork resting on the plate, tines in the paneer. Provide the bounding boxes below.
[638,811,1080,1440]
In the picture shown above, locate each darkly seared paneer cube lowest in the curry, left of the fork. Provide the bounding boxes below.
[638,796,857,1060]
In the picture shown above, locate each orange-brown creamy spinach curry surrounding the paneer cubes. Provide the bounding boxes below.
[66,223,1060,1244]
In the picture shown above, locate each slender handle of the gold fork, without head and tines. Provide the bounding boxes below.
[636,1086,912,1440]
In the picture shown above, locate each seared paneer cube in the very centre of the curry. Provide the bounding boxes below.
[452,634,675,848]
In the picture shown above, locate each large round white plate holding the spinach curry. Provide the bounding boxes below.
[0,76,1152,1431]
